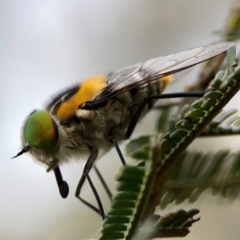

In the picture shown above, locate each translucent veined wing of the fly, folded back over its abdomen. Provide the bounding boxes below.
[89,42,234,105]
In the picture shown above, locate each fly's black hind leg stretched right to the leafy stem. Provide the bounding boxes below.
[126,91,207,139]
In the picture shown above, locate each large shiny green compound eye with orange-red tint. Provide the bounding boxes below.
[23,111,59,151]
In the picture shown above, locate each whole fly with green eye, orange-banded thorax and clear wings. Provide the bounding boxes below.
[15,42,233,218]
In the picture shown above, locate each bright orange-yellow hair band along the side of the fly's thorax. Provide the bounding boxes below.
[57,76,107,120]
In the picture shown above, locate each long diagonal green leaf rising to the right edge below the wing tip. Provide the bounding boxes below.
[143,47,240,214]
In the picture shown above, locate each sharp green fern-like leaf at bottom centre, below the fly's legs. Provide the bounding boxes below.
[99,142,160,240]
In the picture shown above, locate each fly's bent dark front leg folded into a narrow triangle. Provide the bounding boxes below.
[75,150,105,219]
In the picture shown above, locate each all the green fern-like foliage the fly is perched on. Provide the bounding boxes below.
[93,43,240,239]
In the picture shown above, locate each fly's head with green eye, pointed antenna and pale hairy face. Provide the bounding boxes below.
[15,110,60,167]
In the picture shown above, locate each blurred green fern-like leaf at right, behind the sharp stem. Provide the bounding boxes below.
[160,150,240,209]
